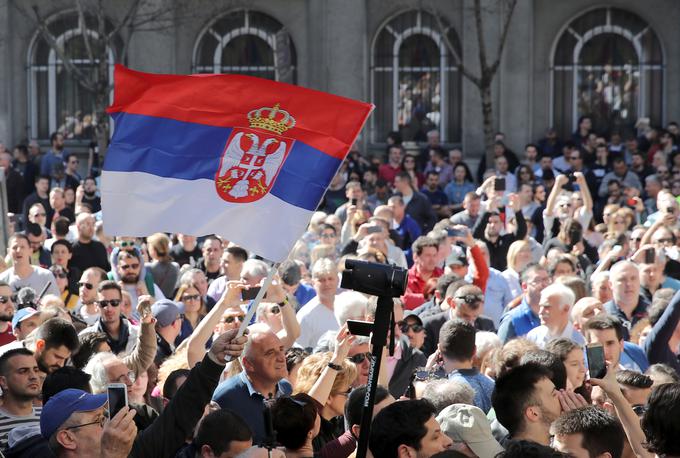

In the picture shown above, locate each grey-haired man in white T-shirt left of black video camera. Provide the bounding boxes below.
[297,259,339,348]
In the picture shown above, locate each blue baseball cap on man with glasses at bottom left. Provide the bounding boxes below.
[40,388,107,439]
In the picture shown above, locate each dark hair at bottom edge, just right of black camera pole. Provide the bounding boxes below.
[368,399,435,457]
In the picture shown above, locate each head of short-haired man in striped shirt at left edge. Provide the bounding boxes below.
[0,348,42,402]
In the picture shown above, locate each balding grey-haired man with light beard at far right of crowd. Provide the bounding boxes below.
[604,261,649,340]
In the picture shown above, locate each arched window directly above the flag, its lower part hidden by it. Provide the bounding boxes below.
[193,10,297,83]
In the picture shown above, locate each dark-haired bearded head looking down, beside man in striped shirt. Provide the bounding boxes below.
[33,318,79,374]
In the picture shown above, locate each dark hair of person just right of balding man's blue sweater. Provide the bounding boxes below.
[271,393,317,450]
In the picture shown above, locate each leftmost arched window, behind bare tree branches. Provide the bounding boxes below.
[28,13,114,140]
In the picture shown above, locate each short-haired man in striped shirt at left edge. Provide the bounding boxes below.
[0,348,42,450]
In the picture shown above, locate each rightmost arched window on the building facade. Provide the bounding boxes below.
[552,8,664,136]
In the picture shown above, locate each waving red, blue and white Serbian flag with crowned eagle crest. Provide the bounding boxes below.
[101,65,373,261]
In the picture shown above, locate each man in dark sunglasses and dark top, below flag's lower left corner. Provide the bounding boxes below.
[80,280,139,358]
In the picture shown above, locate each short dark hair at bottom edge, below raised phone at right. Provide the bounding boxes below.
[552,406,625,458]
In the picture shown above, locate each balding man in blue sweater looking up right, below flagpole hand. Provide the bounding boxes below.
[213,325,292,444]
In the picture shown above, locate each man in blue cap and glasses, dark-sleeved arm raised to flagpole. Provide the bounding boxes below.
[40,331,244,458]
